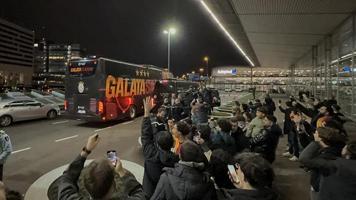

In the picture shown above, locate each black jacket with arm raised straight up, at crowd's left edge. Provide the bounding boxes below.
[141,117,179,198]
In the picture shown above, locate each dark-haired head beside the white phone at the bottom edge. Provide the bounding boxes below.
[234,153,274,189]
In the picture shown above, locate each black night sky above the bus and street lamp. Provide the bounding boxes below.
[0,0,246,75]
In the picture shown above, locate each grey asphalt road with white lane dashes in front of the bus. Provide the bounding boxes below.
[4,117,143,194]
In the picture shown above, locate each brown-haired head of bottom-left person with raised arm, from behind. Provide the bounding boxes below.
[82,159,115,199]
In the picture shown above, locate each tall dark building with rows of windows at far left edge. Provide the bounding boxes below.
[0,19,34,86]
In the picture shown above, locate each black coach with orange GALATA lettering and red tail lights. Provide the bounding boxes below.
[65,58,162,121]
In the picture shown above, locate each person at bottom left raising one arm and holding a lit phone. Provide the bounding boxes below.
[47,134,144,200]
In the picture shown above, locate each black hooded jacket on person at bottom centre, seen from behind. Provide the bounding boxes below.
[151,161,216,200]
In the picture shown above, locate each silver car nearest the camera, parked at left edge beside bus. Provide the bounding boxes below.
[0,99,60,127]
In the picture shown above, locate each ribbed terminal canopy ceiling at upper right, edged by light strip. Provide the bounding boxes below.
[204,0,356,67]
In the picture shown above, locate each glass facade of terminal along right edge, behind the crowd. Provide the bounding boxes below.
[288,15,356,119]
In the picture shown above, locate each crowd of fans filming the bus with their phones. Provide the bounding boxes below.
[0,89,356,200]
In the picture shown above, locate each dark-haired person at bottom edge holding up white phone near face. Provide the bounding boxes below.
[217,153,278,200]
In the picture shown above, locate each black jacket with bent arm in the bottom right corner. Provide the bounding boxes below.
[299,142,356,200]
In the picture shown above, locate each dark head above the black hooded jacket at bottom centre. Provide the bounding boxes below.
[179,140,205,163]
